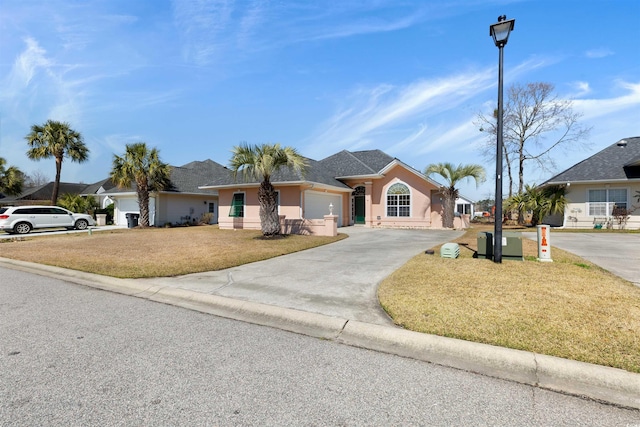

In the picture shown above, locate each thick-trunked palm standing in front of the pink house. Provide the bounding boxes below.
[229,144,307,236]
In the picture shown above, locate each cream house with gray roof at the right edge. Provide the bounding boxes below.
[542,137,640,229]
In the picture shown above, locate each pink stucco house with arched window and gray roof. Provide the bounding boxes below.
[201,150,460,232]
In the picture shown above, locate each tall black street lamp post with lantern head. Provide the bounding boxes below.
[489,15,516,263]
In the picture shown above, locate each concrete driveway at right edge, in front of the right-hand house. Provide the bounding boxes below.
[523,230,640,286]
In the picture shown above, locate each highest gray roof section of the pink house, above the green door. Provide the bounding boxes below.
[320,150,395,177]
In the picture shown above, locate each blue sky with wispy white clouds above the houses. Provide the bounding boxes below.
[0,0,640,200]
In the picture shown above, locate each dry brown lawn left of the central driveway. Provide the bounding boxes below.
[0,226,346,278]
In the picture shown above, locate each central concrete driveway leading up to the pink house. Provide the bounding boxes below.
[138,227,463,325]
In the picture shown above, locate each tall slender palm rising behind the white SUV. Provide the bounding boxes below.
[25,120,89,205]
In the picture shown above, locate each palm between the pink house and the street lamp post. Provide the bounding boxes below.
[424,163,485,228]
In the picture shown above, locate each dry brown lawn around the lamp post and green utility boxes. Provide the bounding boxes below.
[378,228,640,372]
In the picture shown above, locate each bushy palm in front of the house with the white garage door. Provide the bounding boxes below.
[111,142,171,227]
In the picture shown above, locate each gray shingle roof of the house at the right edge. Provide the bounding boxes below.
[542,136,640,185]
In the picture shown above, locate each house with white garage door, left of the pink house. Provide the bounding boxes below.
[100,160,229,226]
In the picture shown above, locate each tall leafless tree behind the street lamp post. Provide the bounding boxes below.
[478,82,591,196]
